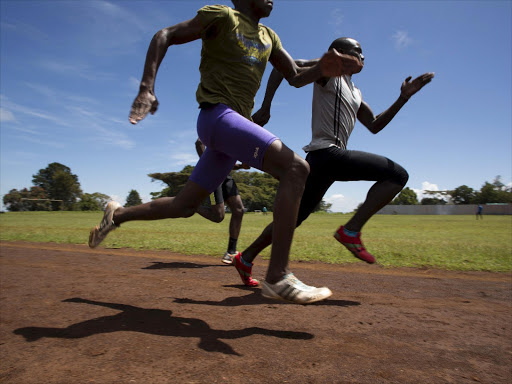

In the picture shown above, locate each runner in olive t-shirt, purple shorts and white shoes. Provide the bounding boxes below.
[89,0,362,304]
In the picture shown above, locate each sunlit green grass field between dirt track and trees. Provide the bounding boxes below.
[0,212,512,272]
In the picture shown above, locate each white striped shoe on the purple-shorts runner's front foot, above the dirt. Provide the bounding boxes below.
[261,273,332,304]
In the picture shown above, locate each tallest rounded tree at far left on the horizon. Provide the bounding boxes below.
[32,163,82,210]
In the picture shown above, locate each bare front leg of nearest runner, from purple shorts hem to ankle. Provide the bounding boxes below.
[263,140,309,284]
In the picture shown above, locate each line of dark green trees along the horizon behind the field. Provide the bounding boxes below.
[3,163,512,212]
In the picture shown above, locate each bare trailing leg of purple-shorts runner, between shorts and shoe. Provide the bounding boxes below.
[113,180,209,225]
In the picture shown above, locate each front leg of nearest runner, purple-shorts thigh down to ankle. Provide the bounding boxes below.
[196,104,309,283]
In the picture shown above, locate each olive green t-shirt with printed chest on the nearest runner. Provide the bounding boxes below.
[196,5,282,120]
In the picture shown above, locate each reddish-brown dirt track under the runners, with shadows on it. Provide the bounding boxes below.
[0,242,512,384]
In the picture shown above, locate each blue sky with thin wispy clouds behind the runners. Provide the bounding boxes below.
[0,0,512,212]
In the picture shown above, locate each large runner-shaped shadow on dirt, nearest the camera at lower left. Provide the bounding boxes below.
[14,298,314,356]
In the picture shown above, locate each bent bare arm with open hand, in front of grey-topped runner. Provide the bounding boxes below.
[357,72,434,134]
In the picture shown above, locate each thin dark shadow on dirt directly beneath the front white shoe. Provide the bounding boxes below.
[174,292,361,307]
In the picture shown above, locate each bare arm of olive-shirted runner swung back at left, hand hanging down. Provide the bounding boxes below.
[129,16,203,124]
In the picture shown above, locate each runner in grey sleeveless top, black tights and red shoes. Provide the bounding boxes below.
[242,37,434,264]
